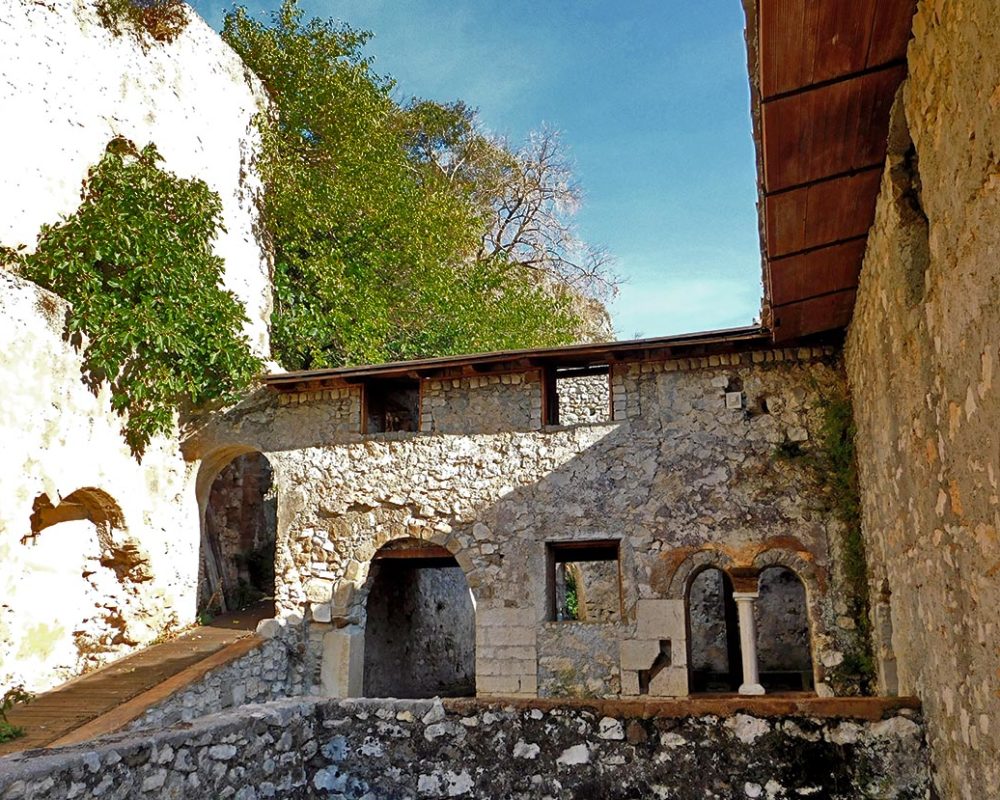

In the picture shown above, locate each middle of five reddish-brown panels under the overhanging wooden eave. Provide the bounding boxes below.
[764,169,882,258]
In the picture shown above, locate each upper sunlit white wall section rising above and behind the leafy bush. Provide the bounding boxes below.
[0,0,271,358]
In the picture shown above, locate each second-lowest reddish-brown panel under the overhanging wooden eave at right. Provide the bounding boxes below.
[768,236,868,306]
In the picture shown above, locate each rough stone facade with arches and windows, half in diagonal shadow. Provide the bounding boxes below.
[188,349,868,696]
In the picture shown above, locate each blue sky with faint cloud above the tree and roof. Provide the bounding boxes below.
[192,0,761,338]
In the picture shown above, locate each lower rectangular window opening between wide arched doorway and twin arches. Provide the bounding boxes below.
[547,540,622,623]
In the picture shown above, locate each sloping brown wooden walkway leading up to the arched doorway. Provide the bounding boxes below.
[0,609,270,756]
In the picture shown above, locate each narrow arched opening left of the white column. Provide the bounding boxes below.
[685,567,743,693]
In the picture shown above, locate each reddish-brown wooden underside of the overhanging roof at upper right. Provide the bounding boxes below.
[747,0,916,342]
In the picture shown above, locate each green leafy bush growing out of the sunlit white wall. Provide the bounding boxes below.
[11,139,261,454]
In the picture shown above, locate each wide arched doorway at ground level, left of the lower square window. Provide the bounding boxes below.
[364,539,476,698]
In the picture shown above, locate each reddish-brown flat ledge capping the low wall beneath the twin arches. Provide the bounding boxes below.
[456,692,920,722]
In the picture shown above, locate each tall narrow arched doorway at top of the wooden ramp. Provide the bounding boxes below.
[198,452,277,627]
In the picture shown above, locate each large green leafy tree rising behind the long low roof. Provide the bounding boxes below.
[223,0,604,368]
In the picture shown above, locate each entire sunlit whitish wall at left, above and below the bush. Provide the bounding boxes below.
[0,0,270,692]
